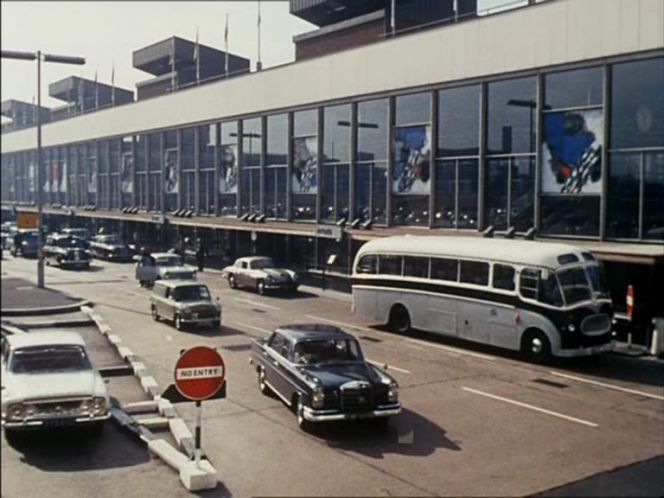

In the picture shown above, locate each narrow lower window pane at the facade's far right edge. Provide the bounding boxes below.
[643,151,664,240]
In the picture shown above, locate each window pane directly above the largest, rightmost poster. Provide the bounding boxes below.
[544,67,604,109]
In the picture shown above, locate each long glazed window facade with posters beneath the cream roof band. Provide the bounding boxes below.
[2,56,664,243]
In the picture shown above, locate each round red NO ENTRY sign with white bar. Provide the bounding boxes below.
[174,346,226,401]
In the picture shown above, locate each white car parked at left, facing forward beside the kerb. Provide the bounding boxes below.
[1,331,110,436]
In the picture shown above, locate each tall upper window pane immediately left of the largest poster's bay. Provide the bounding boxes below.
[487,77,537,154]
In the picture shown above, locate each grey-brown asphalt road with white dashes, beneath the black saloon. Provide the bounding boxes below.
[2,259,664,497]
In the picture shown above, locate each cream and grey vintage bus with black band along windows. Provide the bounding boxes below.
[352,235,613,361]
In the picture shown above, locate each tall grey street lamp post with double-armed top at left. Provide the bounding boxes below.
[2,50,85,289]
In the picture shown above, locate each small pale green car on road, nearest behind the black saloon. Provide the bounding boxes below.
[150,280,221,330]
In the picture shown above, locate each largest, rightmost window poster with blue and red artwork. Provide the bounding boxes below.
[542,109,604,194]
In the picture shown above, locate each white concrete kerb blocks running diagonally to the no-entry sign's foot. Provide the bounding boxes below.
[81,306,217,491]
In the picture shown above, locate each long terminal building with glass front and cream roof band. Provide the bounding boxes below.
[2,0,664,338]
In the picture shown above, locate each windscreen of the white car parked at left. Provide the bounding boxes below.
[9,345,92,374]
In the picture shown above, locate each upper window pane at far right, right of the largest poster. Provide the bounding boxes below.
[611,57,664,149]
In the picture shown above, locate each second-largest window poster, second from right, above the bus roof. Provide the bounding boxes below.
[392,125,431,195]
